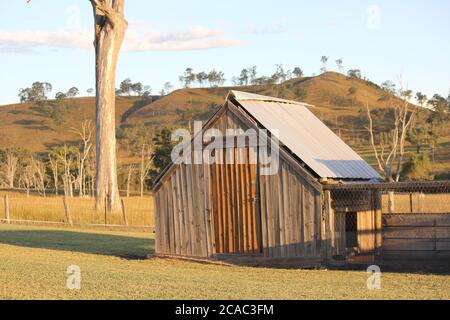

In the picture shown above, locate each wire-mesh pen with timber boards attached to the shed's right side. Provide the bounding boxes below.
[324,181,450,261]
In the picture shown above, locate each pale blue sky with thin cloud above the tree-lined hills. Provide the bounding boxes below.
[0,0,450,104]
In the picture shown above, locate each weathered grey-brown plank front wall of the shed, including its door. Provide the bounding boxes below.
[155,102,322,258]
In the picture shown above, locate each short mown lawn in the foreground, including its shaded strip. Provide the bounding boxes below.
[0,225,450,299]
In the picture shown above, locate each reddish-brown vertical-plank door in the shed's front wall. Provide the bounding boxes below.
[211,148,261,254]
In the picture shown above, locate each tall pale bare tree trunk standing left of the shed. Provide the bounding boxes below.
[91,0,128,210]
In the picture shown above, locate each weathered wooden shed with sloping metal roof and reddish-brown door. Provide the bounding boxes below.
[153,91,380,265]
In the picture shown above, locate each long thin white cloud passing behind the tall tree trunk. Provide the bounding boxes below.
[0,25,243,53]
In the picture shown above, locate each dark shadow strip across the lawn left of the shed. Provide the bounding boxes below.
[0,230,155,260]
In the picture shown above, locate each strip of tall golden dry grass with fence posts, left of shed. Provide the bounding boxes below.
[0,190,154,230]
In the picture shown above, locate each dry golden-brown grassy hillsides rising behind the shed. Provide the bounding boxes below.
[0,72,450,179]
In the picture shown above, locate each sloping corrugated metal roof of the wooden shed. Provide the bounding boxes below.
[230,91,381,179]
